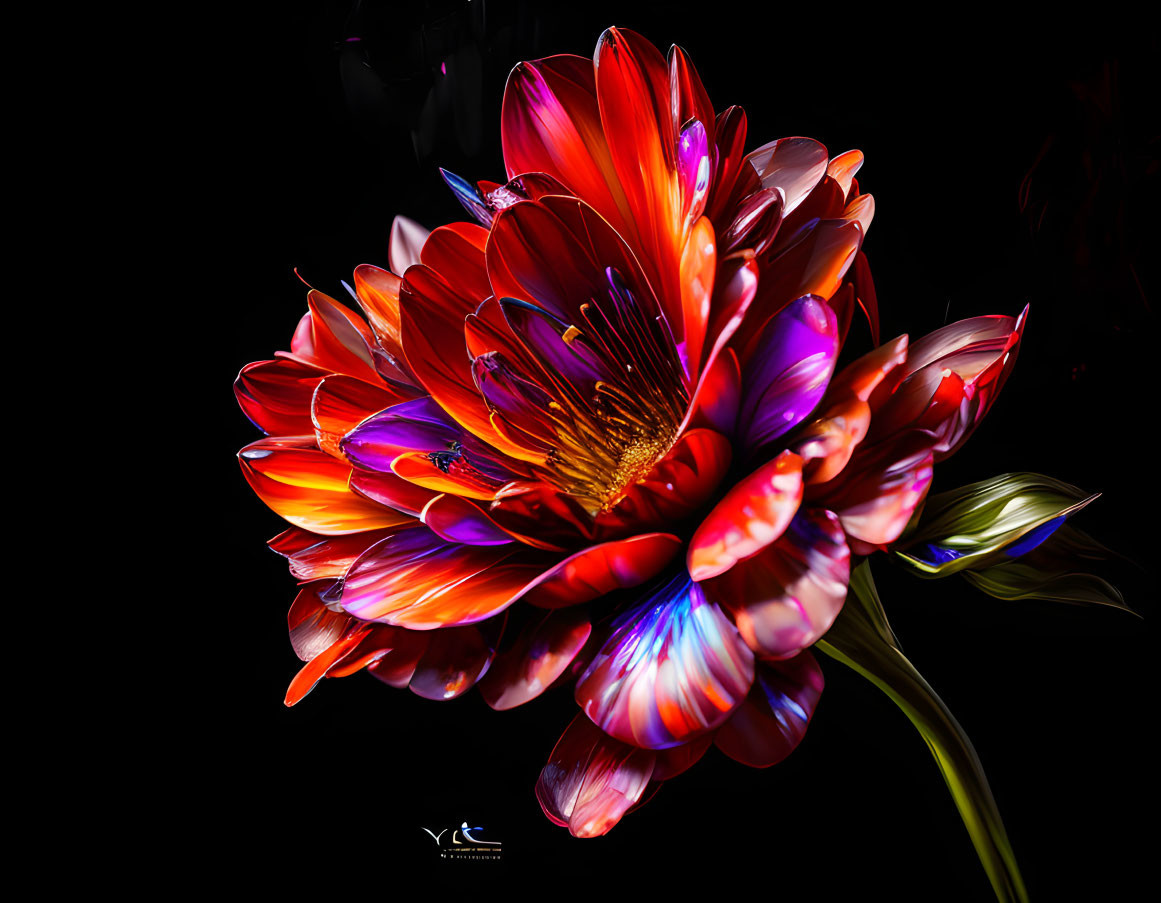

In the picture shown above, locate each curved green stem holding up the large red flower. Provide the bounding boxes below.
[817,561,1027,903]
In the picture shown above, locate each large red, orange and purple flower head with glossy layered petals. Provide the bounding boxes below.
[236,29,1123,884]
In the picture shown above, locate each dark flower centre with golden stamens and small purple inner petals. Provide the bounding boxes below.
[485,268,688,515]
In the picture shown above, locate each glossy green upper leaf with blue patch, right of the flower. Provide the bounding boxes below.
[895,474,1099,577]
